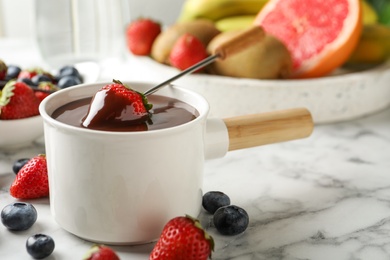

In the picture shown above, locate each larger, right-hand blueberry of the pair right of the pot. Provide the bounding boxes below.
[213,205,249,236]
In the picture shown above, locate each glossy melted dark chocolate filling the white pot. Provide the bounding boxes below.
[51,95,199,132]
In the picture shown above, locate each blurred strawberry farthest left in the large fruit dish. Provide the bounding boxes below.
[126,18,161,56]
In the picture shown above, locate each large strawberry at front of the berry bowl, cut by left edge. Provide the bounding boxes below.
[0,80,39,119]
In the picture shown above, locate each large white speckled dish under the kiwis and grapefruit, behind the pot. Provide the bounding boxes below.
[136,58,390,123]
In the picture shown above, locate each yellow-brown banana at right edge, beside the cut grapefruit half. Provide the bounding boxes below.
[346,24,390,67]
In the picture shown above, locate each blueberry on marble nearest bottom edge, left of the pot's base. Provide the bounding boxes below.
[26,234,55,259]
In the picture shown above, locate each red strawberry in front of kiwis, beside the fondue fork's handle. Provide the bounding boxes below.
[169,33,207,70]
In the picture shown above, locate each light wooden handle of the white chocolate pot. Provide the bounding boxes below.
[223,108,314,151]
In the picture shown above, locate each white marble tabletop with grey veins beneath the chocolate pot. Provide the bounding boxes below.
[0,37,390,260]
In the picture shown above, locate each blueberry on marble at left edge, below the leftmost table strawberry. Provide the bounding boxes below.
[1,202,38,231]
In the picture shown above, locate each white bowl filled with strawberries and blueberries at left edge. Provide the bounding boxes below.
[0,61,83,151]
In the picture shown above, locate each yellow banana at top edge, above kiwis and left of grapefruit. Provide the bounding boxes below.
[178,0,268,22]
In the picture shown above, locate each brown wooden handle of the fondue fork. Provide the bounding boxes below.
[213,26,265,60]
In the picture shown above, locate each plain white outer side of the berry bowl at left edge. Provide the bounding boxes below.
[0,115,43,151]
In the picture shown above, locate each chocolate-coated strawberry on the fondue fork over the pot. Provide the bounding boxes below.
[82,80,152,130]
